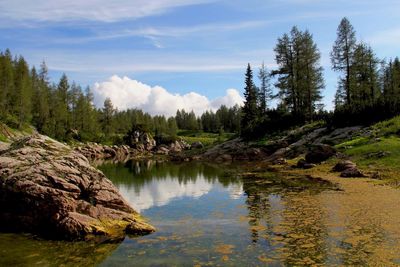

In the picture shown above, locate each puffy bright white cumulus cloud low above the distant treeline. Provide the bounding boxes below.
[92,75,243,116]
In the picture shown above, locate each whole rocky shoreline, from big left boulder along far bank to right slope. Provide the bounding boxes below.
[0,124,368,240]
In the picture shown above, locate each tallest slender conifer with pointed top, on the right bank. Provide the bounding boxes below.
[331,18,356,105]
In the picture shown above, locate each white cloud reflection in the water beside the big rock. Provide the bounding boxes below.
[119,175,213,212]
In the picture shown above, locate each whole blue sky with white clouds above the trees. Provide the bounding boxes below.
[0,0,400,115]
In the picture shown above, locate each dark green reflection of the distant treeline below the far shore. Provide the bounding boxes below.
[99,160,238,191]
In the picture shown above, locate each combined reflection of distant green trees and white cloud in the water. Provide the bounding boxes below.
[100,160,243,212]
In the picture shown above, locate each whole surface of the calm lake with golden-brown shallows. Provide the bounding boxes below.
[0,161,400,266]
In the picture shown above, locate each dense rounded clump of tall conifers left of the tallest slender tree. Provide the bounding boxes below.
[273,27,324,120]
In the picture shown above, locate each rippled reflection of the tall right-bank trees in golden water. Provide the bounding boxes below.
[243,175,333,266]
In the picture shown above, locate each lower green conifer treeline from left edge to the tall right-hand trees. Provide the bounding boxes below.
[0,49,241,143]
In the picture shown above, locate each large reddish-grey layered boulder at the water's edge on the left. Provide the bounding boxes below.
[0,135,154,240]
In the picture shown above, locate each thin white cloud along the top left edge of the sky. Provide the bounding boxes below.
[0,0,216,22]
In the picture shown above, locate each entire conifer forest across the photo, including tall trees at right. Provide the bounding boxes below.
[0,18,400,144]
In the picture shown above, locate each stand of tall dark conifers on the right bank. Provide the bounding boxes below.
[241,18,400,139]
